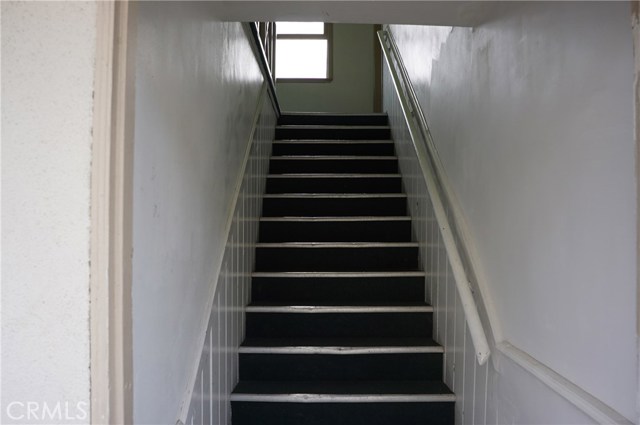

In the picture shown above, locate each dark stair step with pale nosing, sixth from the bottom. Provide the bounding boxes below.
[259,217,411,242]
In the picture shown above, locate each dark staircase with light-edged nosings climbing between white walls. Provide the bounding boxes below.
[231,114,455,425]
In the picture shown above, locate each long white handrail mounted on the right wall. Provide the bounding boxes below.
[378,30,491,365]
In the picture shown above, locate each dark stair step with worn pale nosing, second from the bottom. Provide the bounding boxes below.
[239,337,443,381]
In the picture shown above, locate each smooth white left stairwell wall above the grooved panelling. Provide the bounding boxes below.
[132,2,262,424]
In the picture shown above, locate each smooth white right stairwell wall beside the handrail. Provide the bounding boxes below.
[392,3,637,423]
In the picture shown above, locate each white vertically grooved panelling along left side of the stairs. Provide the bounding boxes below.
[181,96,276,425]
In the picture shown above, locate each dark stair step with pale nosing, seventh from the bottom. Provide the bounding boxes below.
[262,193,407,217]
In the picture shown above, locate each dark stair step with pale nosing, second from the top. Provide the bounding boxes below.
[275,125,391,140]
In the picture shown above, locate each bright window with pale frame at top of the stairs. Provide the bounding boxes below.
[275,22,332,82]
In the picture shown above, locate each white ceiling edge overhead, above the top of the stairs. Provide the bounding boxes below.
[210,0,497,26]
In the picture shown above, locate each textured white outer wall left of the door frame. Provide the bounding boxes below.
[0,2,96,424]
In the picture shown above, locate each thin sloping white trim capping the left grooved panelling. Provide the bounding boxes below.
[176,81,268,424]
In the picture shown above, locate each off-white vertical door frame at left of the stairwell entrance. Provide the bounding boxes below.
[90,1,135,424]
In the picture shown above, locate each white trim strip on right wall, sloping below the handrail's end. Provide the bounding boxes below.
[496,341,633,425]
